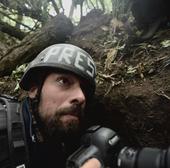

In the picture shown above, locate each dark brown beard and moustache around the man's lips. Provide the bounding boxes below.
[39,104,84,140]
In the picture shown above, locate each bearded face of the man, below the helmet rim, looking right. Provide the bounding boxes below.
[29,73,86,137]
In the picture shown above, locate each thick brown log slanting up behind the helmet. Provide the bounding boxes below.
[0,15,73,76]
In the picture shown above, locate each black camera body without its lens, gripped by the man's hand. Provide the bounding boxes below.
[66,126,120,168]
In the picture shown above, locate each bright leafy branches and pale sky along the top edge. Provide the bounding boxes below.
[0,0,128,37]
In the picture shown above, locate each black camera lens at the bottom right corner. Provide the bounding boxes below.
[117,147,168,168]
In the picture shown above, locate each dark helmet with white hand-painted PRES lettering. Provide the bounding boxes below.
[20,44,96,92]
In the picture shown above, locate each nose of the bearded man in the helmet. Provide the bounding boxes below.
[71,86,86,104]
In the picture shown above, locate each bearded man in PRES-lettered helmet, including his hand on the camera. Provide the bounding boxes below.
[20,44,99,168]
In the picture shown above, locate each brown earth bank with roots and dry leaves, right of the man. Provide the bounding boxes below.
[71,10,170,147]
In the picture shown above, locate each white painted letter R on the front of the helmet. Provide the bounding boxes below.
[58,47,74,64]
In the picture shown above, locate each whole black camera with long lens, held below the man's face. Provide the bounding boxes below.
[66,126,170,168]
